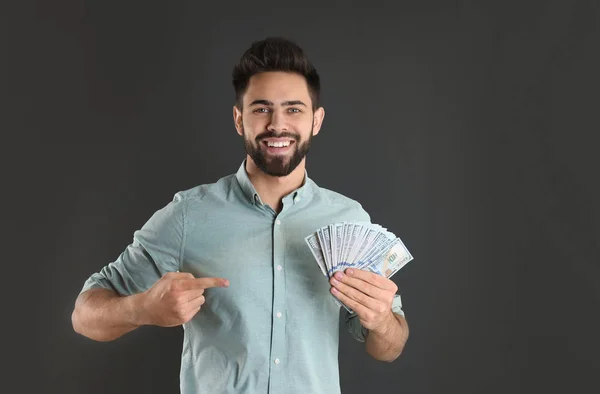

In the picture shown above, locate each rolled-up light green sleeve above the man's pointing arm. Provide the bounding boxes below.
[80,193,186,295]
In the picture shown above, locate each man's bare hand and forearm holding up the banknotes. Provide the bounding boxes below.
[330,268,408,361]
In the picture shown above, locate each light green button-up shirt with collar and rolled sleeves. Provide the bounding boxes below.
[82,161,403,394]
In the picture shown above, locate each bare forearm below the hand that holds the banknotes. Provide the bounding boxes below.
[365,313,408,362]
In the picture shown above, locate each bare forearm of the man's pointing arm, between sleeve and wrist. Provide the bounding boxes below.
[71,288,141,341]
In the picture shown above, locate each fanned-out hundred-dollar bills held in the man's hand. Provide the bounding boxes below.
[305,222,413,312]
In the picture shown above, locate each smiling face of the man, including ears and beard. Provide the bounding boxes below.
[234,72,324,176]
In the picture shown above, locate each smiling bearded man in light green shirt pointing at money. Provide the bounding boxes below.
[72,38,408,394]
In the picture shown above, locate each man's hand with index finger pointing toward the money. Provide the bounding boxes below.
[139,272,229,327]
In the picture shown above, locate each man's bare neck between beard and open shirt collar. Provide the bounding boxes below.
[246,156,306,212]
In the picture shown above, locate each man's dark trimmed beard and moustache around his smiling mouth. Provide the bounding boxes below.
[244,127,313,177]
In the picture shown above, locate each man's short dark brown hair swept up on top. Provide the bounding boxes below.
[232,37,321,111]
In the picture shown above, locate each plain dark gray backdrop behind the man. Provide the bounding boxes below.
[0,0,600,394]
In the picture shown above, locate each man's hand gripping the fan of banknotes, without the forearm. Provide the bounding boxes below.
[329,268,398,331]
